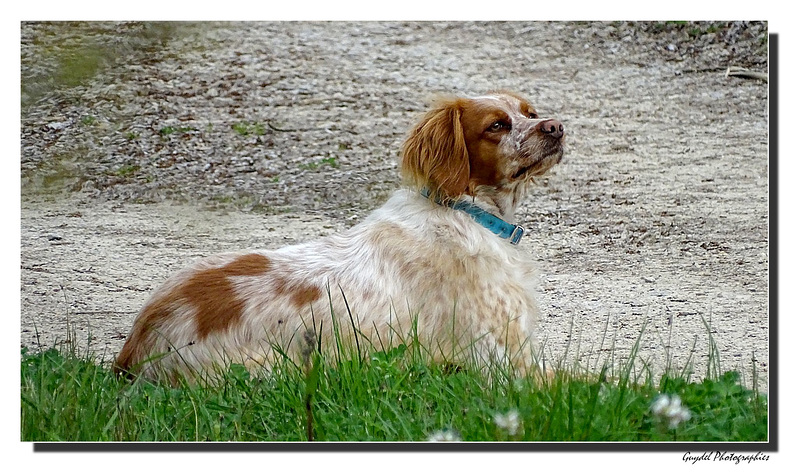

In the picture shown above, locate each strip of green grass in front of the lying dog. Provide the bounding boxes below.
[21,336,768,442]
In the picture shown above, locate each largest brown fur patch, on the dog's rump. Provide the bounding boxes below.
[113,254,271,375]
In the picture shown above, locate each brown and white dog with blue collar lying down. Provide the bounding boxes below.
[113,91,564,383]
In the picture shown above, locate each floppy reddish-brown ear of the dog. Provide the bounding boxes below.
[402,98,469,201]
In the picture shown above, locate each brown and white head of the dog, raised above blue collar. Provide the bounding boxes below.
[402,92,564,200]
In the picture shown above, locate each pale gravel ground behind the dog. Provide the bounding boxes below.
[21,22,769,390]
